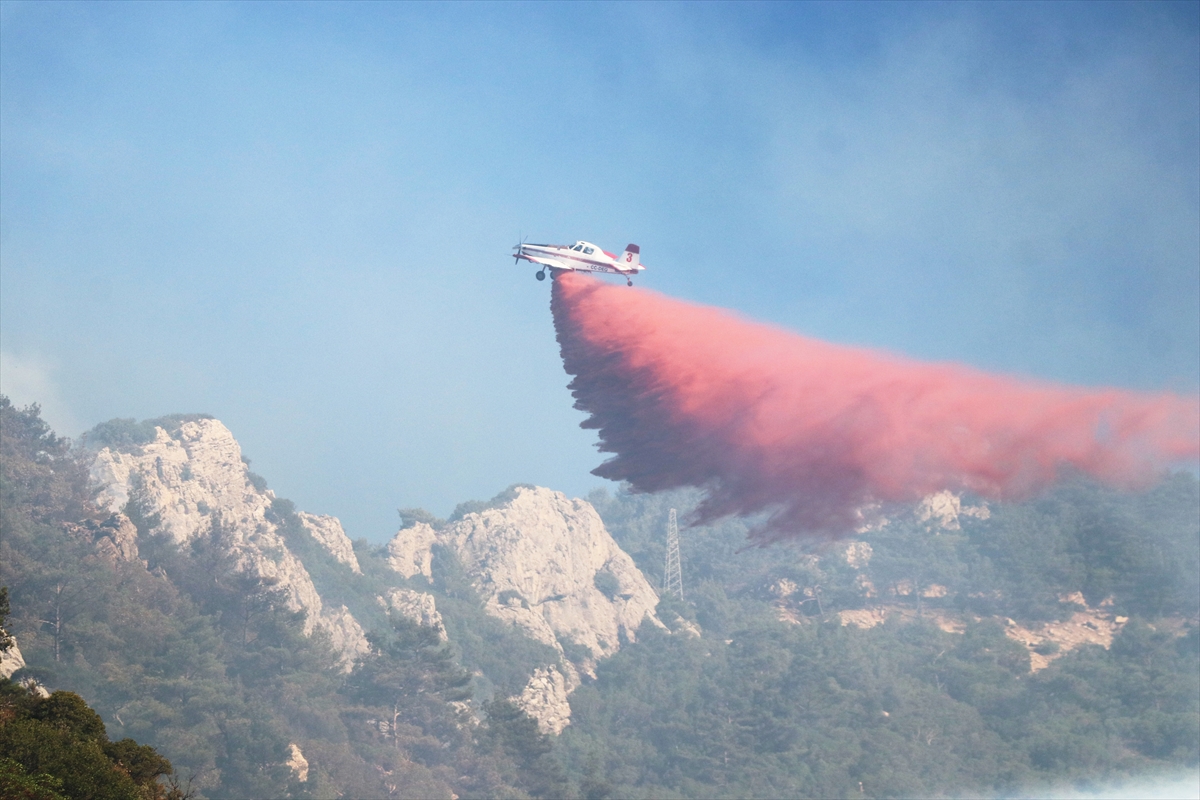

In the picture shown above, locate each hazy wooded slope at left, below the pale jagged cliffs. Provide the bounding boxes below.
[0,398,562,798]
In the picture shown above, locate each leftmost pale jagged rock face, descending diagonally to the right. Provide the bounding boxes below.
[90,420,367,668]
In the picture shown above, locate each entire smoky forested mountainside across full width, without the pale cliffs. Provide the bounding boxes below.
[0,398,1200,798]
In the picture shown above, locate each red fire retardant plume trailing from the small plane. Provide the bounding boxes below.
[551,273,1200,543]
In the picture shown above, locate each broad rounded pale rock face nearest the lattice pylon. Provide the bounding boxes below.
[389,487,659,657]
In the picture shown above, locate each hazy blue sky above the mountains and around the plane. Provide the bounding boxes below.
[0,0,1200,540]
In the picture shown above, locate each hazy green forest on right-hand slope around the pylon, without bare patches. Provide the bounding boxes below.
[558,474,1200,798]
